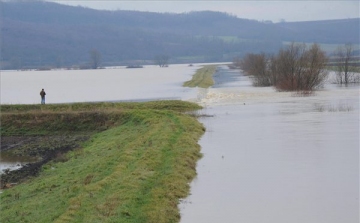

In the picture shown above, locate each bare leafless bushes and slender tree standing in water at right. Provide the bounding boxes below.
[233,43,359,93]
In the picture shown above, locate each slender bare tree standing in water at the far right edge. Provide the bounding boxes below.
[335,44,357,85]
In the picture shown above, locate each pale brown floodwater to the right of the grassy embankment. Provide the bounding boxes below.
[179,67,359,223]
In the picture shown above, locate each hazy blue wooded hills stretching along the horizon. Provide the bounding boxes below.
[0,1,360,69]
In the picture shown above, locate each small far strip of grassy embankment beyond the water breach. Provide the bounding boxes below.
[183,65,217,88]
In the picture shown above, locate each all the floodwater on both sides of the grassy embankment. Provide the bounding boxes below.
[1,65,359,223]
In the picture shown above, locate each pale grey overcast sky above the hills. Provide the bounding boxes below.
[47,0,360,22]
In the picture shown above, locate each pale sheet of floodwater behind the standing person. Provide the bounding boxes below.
[1,65,199,104]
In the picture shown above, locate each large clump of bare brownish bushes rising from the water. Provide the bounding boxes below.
[240,43,328,93]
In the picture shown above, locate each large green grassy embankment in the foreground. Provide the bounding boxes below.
[0,101,204,223]
